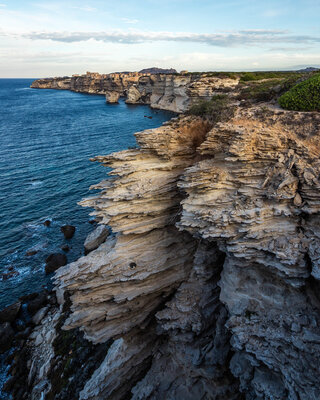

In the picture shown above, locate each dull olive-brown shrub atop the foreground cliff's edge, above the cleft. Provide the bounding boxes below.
[188,94,234,123]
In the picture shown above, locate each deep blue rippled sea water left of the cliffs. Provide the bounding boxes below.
[0,79,173,309]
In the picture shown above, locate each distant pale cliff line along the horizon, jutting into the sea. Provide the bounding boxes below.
[31,72,239,113]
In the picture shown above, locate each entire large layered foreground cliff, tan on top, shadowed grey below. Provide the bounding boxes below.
[51,107,320,400]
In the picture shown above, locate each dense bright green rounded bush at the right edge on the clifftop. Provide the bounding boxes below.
[279,73,320,111]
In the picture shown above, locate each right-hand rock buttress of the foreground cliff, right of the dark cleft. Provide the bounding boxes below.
[179,110,320,399]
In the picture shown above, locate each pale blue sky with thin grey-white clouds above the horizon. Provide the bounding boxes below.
[0,0,320,78]
